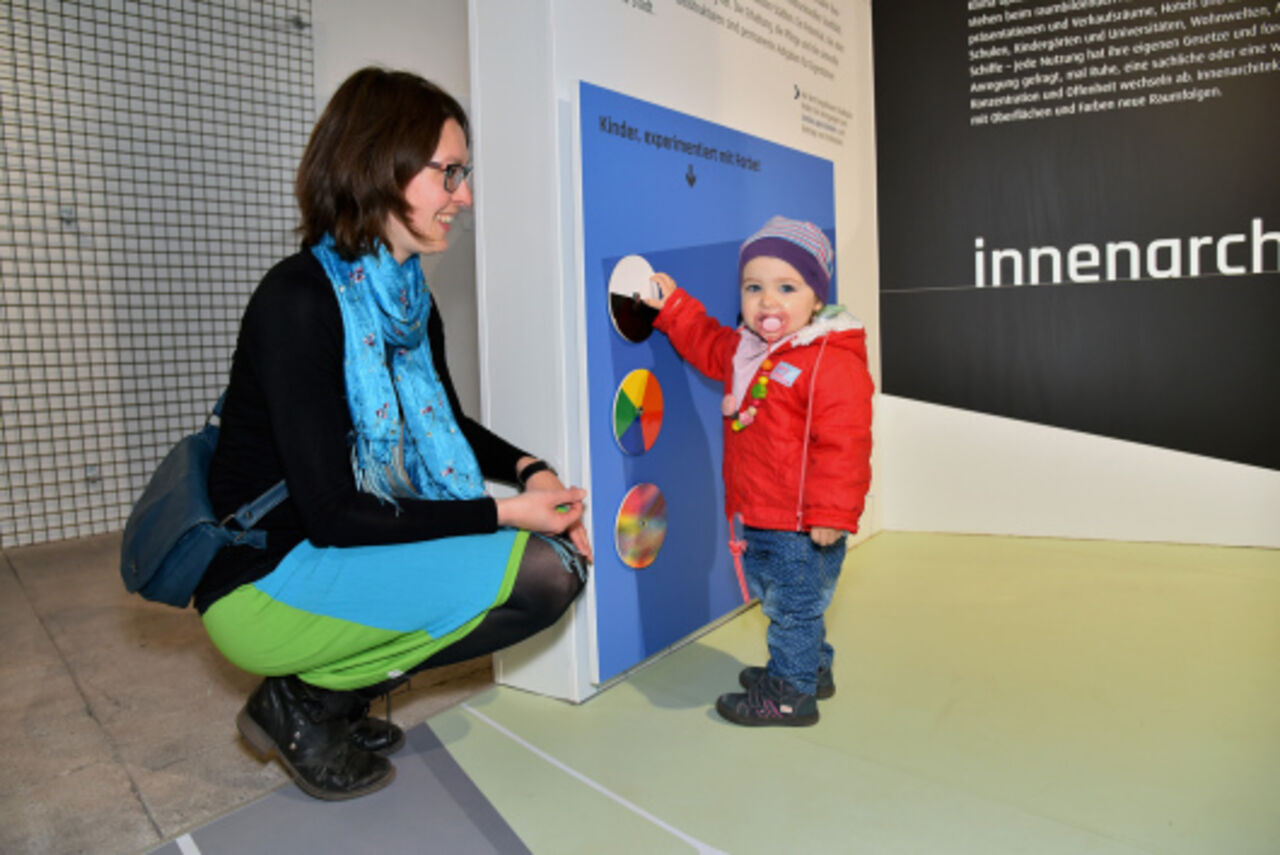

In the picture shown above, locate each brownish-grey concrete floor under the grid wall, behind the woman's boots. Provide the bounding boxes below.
[0,535,493,855]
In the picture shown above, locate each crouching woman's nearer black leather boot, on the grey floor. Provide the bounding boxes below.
[236,676,396,801]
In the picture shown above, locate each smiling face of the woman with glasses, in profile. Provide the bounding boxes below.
[385,119,471,264]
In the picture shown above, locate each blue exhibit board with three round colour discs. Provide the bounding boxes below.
[579,83,838,681]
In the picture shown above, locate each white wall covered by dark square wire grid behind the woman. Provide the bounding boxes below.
[0,0,314,547]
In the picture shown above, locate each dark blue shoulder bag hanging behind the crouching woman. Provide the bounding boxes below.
[120,393,289,608]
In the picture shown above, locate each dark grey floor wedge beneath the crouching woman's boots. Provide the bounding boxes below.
[154,724,529,855]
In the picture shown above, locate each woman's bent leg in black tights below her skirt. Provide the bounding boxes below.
[358,536,586,698]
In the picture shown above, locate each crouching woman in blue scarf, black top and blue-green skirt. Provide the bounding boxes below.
[196,68,590,799]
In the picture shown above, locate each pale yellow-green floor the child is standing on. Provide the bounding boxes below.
[430,534,1280,855]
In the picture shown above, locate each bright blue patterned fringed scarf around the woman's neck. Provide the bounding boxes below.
[311,236,485,504]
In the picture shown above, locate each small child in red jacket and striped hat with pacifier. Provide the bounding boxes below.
[649,216,873,726]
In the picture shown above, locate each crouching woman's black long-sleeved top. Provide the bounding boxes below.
[195,251,526,612]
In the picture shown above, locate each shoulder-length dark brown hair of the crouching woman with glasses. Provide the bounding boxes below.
[293,68,471,259]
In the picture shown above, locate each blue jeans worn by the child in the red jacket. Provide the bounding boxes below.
[742,526,845,695]
